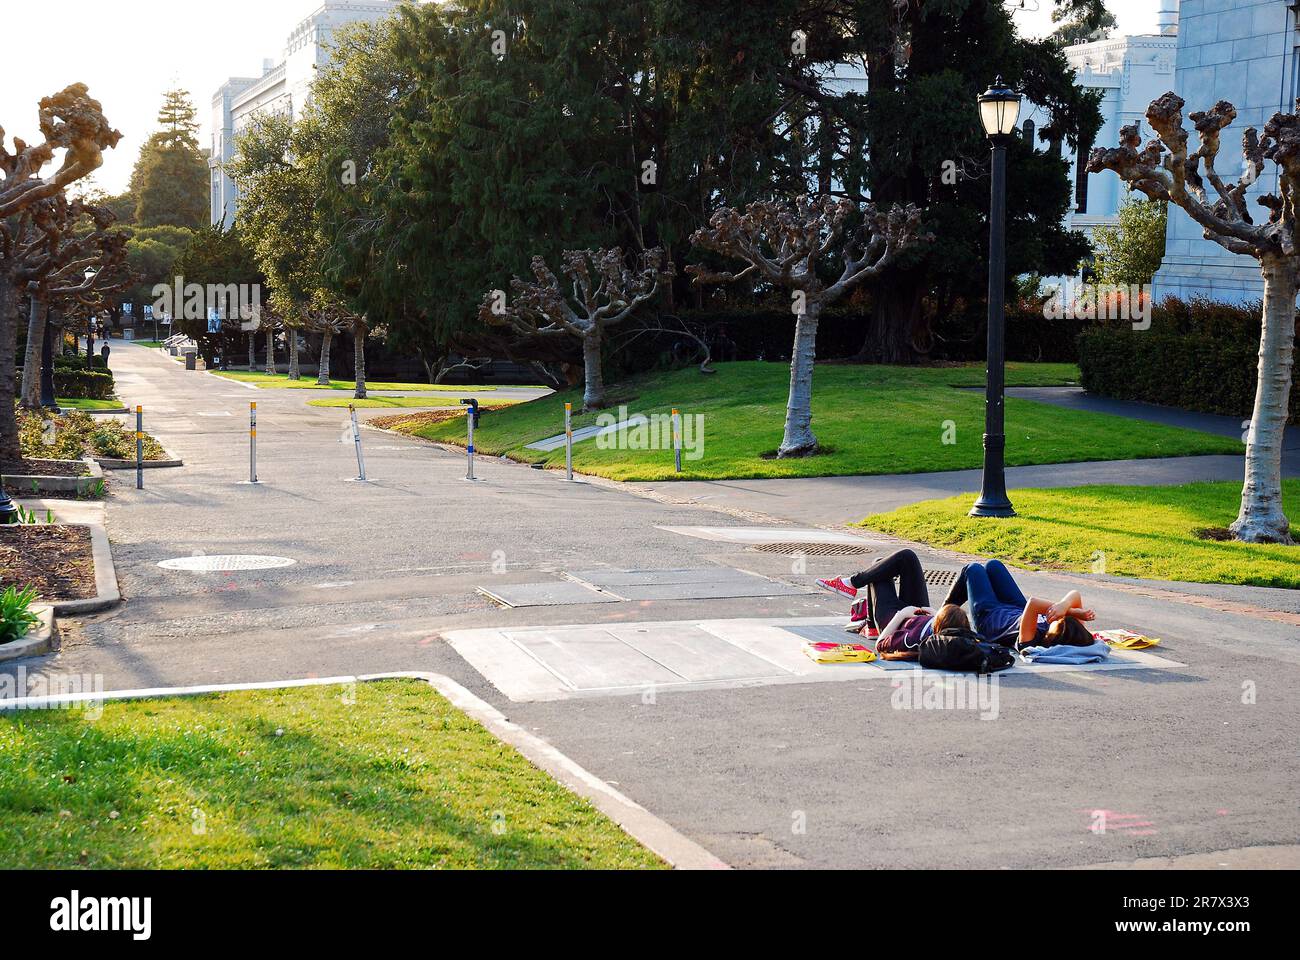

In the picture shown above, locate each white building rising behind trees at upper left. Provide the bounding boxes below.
[208,0,400,226]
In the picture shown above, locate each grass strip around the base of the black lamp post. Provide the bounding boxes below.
[862,480,1300,589]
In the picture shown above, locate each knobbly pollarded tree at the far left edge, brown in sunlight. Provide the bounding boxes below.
[0,83,122,460]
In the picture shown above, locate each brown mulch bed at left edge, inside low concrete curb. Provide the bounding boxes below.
[0,526,96,602]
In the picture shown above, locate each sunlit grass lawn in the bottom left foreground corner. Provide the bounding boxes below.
[0,680,664,869]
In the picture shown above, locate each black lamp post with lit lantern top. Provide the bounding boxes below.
[970,77,1021,516]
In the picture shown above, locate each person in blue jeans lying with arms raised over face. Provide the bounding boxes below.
[944,559,1096,648]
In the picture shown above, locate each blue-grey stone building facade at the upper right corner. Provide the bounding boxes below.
[1154,0,1300,303]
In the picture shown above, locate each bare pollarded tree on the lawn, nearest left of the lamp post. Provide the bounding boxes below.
[686,195,928,458]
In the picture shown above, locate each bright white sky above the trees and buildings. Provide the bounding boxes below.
[0,0,1157,194]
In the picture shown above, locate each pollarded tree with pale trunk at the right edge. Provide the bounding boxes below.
[1088,92,1300,544]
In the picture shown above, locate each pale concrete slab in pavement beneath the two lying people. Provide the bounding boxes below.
[443,617,1183,702]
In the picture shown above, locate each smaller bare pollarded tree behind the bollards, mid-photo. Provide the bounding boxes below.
[478,247,675,410]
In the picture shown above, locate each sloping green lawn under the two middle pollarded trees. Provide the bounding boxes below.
[392,363,1243,480]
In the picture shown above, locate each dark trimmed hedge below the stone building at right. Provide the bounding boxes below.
[1079,300,1300,423]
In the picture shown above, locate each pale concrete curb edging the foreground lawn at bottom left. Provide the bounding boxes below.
[0,671,731,870]
